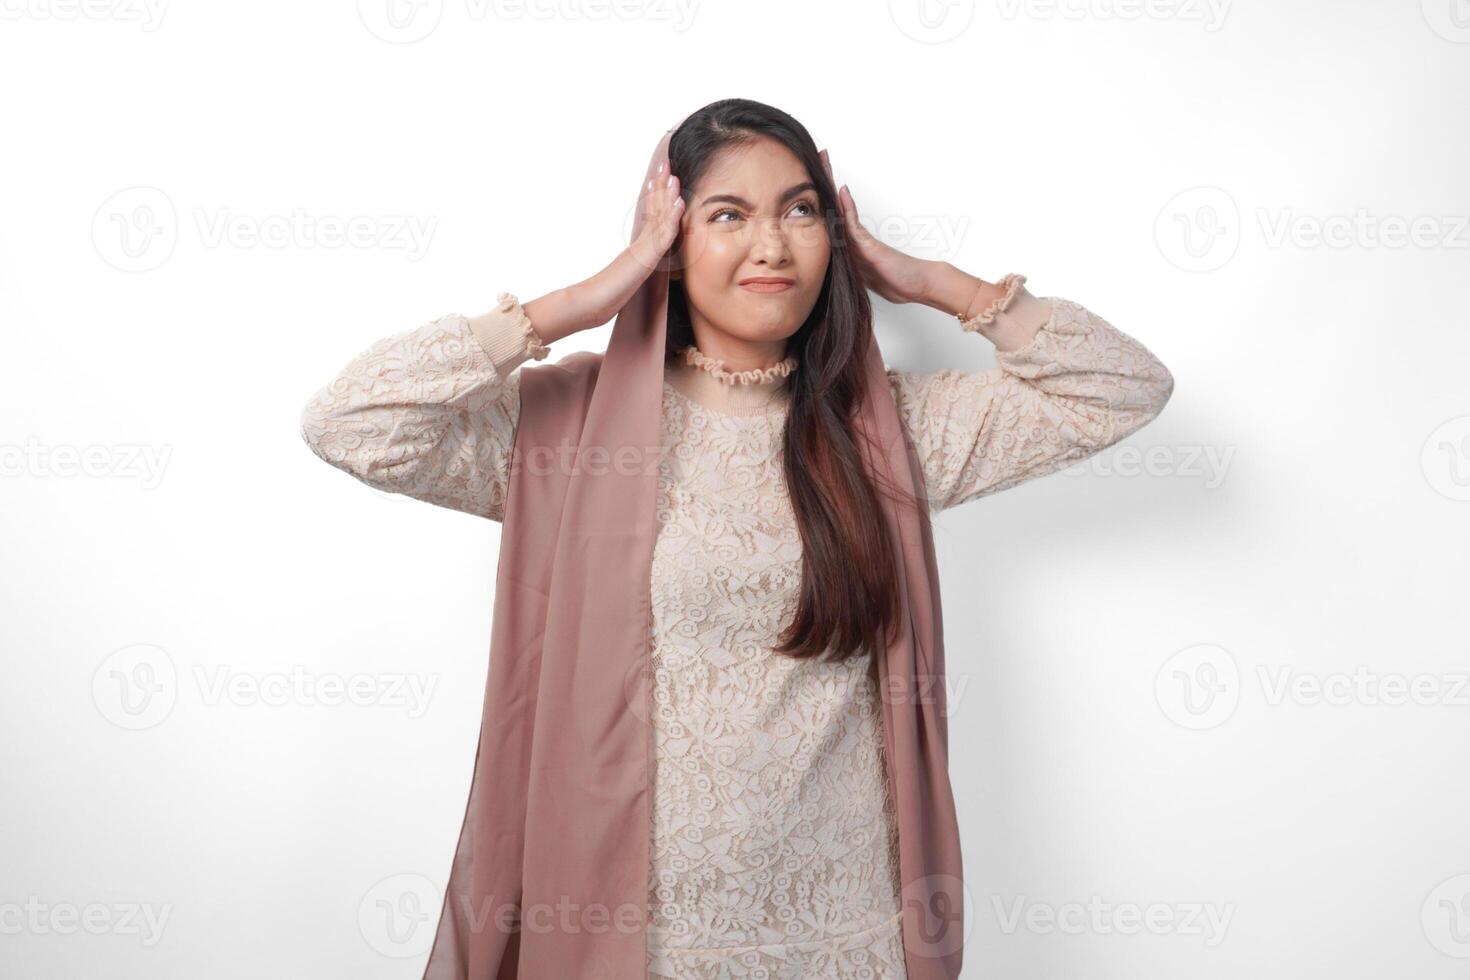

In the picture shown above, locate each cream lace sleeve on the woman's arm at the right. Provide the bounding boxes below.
[888,275,1175,511]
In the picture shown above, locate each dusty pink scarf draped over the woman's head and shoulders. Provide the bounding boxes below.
[423,129,964,980]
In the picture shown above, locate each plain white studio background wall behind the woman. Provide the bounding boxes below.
[0,0,1470,980]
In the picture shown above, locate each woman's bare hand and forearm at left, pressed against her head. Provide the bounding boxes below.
[523,163,684,344]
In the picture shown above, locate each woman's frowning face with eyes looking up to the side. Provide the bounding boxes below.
[678,137,831,351]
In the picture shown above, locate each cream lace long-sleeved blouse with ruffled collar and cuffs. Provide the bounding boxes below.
[301,276,1173,980]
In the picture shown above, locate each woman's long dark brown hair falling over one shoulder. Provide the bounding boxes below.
[666,98,914,660]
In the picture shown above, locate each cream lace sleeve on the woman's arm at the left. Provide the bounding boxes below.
[301,292,548,520]
